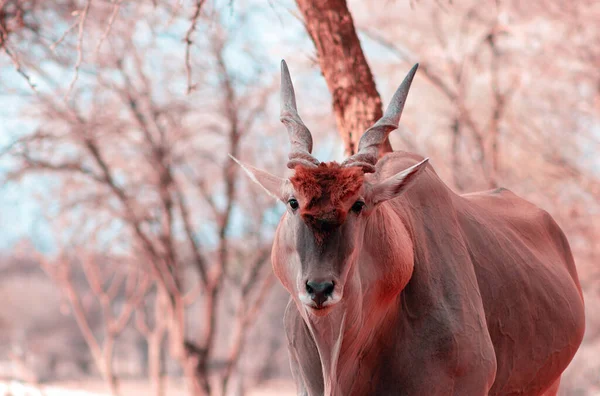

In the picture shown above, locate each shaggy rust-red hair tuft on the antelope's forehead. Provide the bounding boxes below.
[290,162,364,232]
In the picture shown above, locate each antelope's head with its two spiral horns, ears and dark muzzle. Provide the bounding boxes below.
[234,61,427,316]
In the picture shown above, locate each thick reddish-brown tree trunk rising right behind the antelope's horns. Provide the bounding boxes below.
[296,0,392,155]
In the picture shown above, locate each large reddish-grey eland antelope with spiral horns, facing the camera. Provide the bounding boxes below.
[234,62,584,396]
